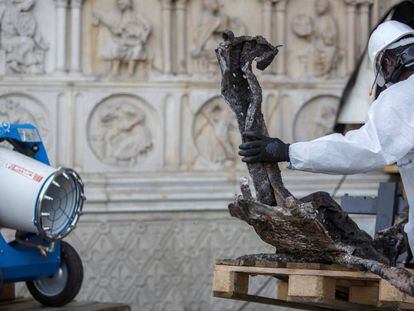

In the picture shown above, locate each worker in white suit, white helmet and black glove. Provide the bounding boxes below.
[239,21,414,258]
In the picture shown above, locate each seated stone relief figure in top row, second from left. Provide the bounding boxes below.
[94,0,152,76]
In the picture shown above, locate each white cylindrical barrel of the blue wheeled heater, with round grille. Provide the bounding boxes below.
[0,147,84,240]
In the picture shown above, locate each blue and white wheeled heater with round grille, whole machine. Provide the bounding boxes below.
[0,124,85,307]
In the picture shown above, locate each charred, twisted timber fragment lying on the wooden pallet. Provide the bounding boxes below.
[216,31,414,296]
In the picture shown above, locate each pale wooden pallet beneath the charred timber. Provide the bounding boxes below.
[213,260,414,311]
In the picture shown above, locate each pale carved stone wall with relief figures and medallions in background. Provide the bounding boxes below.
[0,0,388,311]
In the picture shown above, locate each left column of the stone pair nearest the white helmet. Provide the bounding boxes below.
[344,0,356,73]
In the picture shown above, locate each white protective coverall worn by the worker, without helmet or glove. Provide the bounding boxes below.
[289,75,414,250]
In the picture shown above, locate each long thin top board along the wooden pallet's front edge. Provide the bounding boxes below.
[215,265,381,281]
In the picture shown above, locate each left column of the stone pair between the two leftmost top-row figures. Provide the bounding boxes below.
[54,0,68,73]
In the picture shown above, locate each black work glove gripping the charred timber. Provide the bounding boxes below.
[239,132,289,163]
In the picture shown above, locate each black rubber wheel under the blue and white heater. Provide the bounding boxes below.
[26,241,83,307]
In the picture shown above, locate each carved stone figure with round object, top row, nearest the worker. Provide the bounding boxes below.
[291,0,342,78]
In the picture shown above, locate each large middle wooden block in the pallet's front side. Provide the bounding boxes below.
[287,275,335,304]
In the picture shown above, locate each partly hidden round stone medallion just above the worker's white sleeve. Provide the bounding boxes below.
[293,96,339,141]
